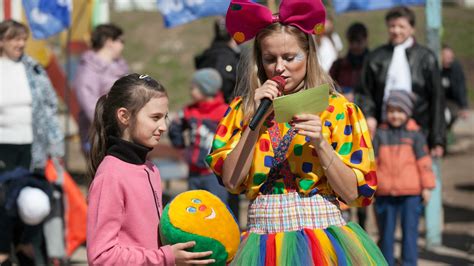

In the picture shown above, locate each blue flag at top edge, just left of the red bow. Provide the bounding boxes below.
[157,0,230,28]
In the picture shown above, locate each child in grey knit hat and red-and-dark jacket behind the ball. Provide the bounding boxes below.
[169,68,228,204]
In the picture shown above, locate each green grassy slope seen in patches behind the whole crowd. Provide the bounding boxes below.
[111,6,474,110]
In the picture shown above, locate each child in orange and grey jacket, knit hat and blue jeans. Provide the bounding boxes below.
[373,90,435,265]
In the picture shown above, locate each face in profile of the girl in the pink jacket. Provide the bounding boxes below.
[128,95,168,148]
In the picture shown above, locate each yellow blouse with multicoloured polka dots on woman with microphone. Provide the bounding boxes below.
[207,94,377,206]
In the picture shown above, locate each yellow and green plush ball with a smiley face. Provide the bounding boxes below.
[160,190,240,265]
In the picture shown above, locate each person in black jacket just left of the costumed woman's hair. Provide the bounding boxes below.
[194,17,240,103]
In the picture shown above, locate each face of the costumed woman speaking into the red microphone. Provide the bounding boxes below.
[260,32,307,94]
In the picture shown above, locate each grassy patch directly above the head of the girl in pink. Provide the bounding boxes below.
[112,12,213,110]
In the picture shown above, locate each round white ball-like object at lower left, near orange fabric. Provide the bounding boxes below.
[16,187,51,225]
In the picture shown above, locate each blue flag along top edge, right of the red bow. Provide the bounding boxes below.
[332,0,426,13]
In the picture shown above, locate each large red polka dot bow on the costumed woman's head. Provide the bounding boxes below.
[226,0,326,44]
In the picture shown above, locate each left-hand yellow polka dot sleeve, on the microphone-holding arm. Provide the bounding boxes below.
[206,97,245,194]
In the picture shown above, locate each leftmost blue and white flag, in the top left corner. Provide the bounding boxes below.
[23,0,72,39]
